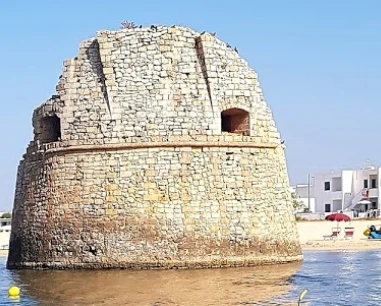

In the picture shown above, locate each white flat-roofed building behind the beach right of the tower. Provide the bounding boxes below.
[302,166,381,213]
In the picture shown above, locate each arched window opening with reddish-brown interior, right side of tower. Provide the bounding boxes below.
[221,108,250,136]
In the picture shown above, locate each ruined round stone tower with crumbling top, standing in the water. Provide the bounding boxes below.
[8,27,302,268]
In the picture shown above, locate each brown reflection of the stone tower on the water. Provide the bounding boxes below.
[16,263,301,306]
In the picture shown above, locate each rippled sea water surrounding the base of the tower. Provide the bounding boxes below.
[0,251,381,306]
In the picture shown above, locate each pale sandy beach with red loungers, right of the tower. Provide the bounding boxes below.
[297,219,381,251]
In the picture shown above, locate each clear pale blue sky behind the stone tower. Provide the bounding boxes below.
[0,0,381,210]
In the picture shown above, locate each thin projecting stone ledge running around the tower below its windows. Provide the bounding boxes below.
[46,141,281,153]
